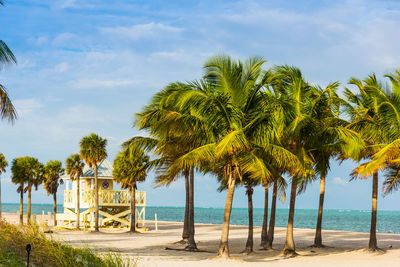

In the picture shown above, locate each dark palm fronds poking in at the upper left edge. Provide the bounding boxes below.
[0,1,17,122]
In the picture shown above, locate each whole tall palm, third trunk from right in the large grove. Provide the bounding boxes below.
[274,66,316,256]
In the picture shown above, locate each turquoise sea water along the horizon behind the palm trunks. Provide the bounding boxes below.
[2,204,400,234]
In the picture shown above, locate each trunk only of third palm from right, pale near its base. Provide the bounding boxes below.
[282,177,297,256]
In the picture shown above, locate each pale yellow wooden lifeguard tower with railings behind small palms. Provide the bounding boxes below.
[57,160,146,227]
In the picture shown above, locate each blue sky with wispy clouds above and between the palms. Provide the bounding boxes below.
[0,0,400,210]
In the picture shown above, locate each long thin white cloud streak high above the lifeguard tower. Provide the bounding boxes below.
[100,22,183,40]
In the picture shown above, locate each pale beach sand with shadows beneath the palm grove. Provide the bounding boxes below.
[1,214,400,267]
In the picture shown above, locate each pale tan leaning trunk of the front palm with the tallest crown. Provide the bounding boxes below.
[218,165,235,258]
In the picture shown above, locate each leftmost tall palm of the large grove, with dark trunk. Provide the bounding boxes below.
[134,83,207,251]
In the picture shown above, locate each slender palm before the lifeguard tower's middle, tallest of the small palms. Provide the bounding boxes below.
[79,133,107,232]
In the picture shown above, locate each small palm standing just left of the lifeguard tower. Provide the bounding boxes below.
[44,160,64,226]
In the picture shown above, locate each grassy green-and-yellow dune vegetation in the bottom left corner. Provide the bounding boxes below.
[0,220,137,267]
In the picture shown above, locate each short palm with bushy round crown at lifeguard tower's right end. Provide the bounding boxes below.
[113,146,150,233]
